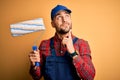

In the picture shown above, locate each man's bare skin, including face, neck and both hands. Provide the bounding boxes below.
[29,10,77,66]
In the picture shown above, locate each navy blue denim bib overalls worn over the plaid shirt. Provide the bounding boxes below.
[43,38,80,80]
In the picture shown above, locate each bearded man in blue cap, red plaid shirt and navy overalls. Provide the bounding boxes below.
[29,5,95,80]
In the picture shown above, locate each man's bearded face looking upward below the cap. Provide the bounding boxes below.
[52,10,72,34]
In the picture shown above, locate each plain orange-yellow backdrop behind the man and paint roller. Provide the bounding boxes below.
[0,0,120,80]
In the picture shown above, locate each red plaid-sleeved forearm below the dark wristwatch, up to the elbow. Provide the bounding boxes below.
[73,56,95,80]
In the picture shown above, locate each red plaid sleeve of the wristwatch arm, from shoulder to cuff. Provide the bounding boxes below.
[73,40,95,80]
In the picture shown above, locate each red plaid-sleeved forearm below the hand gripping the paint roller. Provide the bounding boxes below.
[30,65,42,80]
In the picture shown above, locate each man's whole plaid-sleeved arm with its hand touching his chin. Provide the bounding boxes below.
[62,31,95,80]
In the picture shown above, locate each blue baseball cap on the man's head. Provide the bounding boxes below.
[51,5,72,20]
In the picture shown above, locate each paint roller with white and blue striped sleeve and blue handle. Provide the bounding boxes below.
[10,18,45,66]
